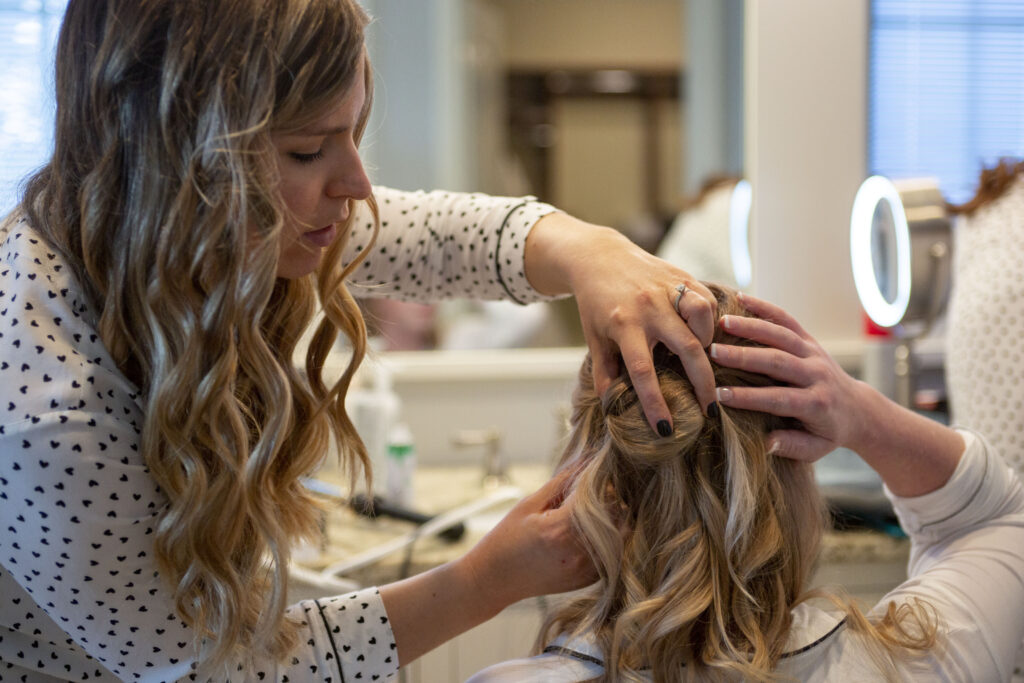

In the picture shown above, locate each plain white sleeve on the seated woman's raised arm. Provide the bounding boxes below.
[873,431,1024,681]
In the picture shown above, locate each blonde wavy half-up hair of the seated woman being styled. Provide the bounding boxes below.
[537,284,937,681]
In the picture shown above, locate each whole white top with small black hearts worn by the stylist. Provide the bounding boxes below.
[0,188,554,683]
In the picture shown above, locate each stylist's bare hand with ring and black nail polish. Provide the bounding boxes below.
[526,213,717,433]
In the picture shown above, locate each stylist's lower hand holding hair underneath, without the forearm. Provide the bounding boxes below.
[462,470,597,608]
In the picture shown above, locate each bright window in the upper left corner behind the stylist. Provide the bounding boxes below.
[0,0,68,215]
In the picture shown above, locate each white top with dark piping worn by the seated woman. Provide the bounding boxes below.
[468,431,1024,683]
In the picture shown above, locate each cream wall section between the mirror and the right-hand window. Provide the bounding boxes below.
[744,0,868,347]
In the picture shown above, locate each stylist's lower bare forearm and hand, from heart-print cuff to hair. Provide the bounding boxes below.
[381,472,597,666]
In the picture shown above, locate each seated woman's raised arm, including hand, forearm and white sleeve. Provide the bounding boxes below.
[712,296,1024,681]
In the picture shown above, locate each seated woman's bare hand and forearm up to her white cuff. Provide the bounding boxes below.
[711,295,964,497]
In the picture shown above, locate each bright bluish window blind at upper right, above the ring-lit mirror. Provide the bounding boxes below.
[868,0,1024,202]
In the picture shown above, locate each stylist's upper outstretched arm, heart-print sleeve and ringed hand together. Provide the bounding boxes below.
[346,187,716,432]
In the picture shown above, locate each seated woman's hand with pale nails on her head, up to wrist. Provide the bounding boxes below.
[711,294,878,462]
